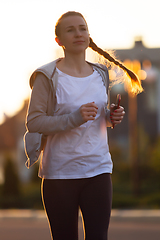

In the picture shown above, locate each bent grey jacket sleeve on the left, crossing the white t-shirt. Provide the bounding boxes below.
[26,73,84,135]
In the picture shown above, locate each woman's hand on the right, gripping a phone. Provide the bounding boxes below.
[110,103,125,127]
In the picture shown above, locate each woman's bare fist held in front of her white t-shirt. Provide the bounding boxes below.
[80,102,98,122]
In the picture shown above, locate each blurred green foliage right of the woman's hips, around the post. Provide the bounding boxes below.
[110,131,160,208]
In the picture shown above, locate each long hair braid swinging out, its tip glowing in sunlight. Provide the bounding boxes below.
[89,38,143,94]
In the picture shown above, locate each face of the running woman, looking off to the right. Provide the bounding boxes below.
[56,16,89,53]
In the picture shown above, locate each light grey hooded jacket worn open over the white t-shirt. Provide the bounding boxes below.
[26,59,112,168]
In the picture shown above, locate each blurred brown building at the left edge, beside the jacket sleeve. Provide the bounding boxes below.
[0,100,29,183]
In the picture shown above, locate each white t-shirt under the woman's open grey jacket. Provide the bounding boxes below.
[39,69,112,179]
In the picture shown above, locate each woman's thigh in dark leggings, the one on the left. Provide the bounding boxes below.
[42,179,79,240]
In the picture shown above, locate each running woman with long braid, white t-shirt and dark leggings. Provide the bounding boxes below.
[27,12,142,240]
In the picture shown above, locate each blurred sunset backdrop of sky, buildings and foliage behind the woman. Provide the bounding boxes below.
[0,0,160,209]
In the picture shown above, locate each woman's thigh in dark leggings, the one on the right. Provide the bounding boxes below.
[80,173,112,240]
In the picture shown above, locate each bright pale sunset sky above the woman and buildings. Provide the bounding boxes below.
[0,0,160,124]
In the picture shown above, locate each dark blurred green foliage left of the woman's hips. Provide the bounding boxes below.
[0,156,42,209]
